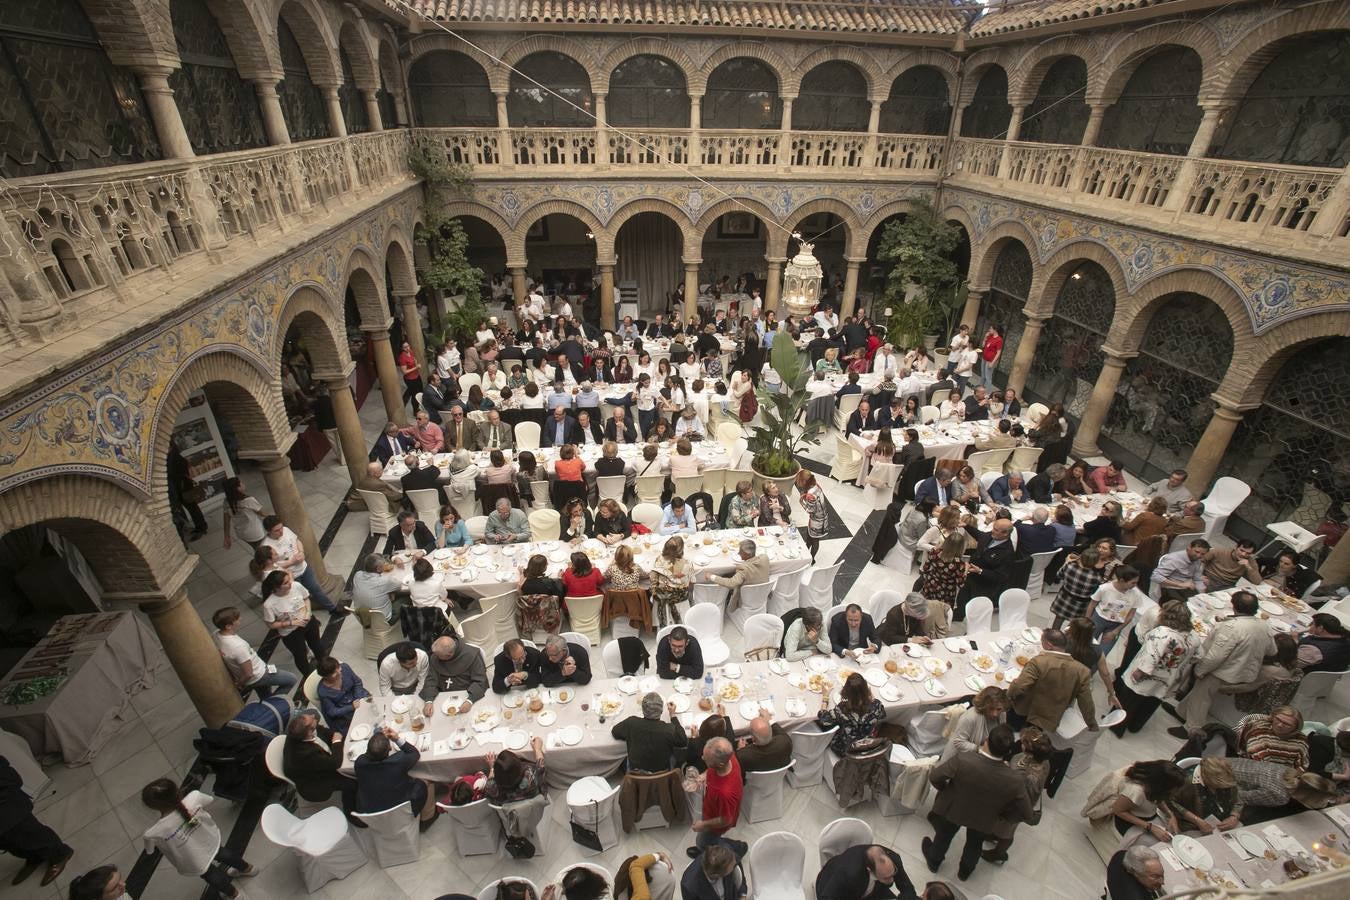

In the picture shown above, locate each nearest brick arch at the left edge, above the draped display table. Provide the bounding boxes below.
[0,472,179,595]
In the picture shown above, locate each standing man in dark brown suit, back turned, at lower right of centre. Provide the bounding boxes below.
[922,725,1031,881]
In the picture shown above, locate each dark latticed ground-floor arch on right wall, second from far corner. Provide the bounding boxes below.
[1026,262,1115,418]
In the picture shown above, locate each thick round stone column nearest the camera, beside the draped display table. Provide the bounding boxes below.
[140,588,243,729]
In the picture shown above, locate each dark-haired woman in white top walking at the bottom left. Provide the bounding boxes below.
[140,779,258,900]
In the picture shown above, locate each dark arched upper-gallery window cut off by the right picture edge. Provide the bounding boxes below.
[1214,31,1350,167]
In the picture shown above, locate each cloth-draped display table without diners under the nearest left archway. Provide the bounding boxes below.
[0,613,167,765]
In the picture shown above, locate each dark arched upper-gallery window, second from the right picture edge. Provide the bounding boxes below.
[1098,47,1202,155]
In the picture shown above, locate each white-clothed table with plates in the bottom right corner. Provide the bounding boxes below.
[1154,804,1350,895]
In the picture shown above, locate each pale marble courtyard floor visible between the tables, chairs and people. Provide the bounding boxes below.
[0,394,1350,900]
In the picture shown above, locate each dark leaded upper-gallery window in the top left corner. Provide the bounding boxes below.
[0,0,159,178]
